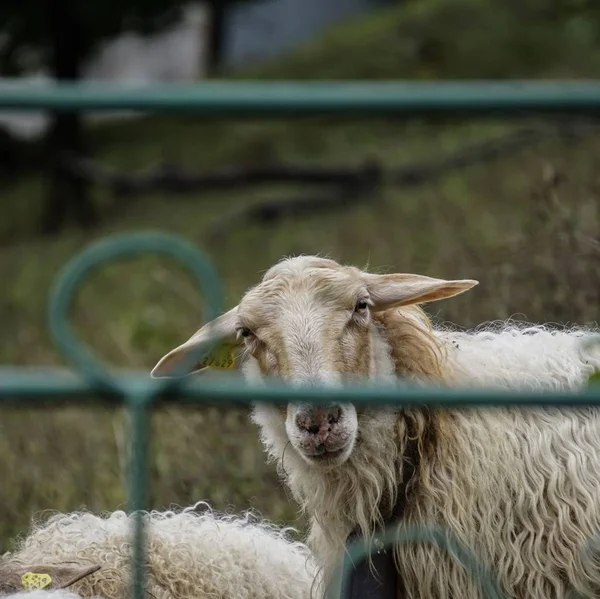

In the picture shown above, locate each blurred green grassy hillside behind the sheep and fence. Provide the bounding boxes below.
[0,0,600,551]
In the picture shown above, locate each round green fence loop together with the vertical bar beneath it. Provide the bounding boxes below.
[48,231,229,599]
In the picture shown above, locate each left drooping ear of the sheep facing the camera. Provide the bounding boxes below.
[150,306,240,379]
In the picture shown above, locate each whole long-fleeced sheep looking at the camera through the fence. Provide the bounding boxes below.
[152,256,600,599]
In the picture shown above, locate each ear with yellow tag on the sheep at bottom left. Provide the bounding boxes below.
[0,561,100,591]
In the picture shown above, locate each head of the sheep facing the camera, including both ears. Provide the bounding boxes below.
[152,256,477,465]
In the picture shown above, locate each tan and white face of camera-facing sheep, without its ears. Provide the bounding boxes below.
[236,259,373,465]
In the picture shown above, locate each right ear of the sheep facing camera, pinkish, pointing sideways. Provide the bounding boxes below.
[364,274,479,311]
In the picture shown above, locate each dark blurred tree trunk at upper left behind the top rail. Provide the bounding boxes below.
[42,0,98,233]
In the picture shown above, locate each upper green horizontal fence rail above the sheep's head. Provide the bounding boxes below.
[0,80,600,117]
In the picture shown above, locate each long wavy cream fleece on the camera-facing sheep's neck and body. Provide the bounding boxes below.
[253,322,600,599]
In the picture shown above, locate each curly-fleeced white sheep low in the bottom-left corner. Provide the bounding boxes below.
[0,503,315,599]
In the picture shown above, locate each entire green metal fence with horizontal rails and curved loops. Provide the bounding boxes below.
[0,81,600,599]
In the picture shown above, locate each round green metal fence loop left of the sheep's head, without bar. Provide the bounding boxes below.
[48,231,222,402]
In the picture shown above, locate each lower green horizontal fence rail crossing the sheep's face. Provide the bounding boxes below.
[0,366,600,408]
